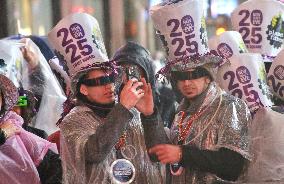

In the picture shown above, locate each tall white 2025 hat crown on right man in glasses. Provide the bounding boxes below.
[150,0,209,60]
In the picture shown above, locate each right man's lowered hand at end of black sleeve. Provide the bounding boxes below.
[149,144,182,164]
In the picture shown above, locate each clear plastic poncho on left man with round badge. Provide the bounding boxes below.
[60,106,163,184]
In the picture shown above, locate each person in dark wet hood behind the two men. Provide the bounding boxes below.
[113,41,176,127]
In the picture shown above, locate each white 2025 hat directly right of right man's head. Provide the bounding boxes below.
[217,53,272,112]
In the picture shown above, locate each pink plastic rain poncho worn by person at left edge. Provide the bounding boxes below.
[0,112,57,184]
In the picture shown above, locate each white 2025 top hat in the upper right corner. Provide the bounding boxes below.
[231,0,284,56]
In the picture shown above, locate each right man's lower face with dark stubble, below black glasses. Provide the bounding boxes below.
[177,76,210,99]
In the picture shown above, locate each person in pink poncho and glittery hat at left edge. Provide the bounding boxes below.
[0,74,61,184]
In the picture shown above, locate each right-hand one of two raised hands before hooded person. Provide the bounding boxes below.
[135,78,154,116]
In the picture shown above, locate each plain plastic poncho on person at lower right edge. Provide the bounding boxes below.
[248,108,284,183]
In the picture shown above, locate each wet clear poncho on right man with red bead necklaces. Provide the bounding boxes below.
[170,82,251,184]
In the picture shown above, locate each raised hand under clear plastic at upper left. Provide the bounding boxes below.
[20,39,39,70]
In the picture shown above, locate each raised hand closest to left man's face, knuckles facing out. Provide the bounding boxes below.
[120,79,144,110]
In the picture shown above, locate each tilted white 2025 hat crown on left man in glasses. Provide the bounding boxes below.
[48,13,108,78]
